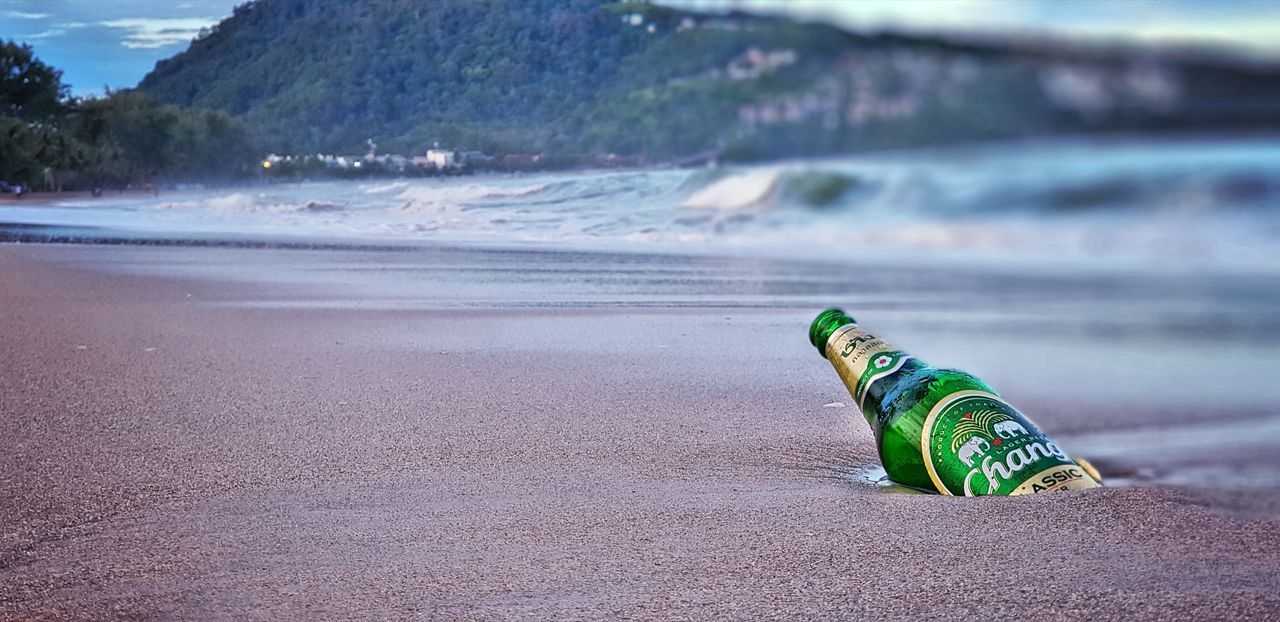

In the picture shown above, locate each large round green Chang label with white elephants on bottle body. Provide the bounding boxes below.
[920,390,1098,497]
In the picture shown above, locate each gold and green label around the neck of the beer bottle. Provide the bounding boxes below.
[823,323,924,427]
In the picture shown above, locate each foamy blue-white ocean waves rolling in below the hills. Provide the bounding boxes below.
[3,138,1280,270]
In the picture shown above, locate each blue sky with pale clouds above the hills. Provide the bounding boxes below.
[0,0,1280,96]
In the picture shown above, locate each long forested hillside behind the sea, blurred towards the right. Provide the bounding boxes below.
[140,0,1280,159]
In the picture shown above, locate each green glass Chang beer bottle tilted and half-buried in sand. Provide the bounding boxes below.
[809,308,1100,497]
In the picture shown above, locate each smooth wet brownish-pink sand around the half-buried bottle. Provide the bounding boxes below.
[0,244,1280,619]
